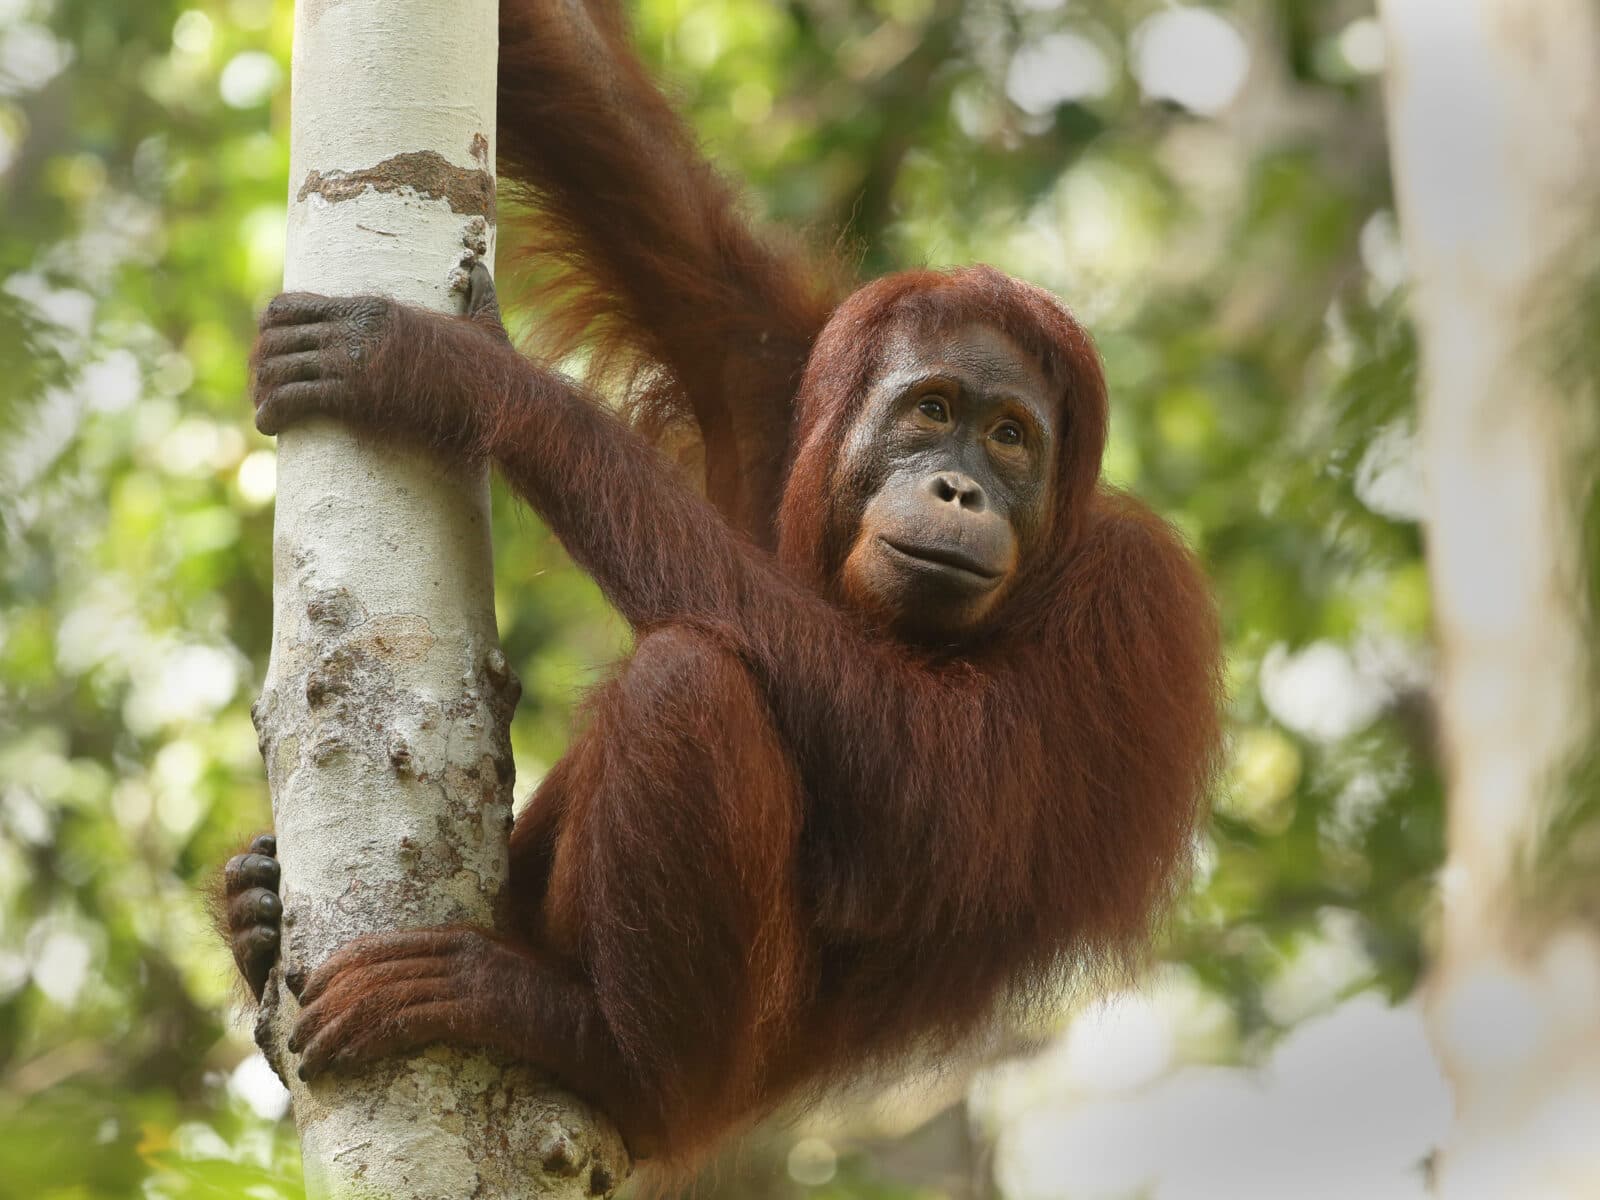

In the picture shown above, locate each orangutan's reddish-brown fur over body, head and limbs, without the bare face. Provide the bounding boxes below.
[225,0,1221,1184]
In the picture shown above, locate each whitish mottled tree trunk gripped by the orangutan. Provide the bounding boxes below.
[256,0,626,1200]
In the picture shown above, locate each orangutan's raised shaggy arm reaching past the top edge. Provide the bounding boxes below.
[499,0,848,546]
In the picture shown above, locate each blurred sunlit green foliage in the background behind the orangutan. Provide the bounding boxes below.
[0,0,1442,1200]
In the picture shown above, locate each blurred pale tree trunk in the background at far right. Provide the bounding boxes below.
[1382,0,1600,1200]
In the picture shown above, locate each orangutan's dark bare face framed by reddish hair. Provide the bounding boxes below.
[838,325,1059,638]
